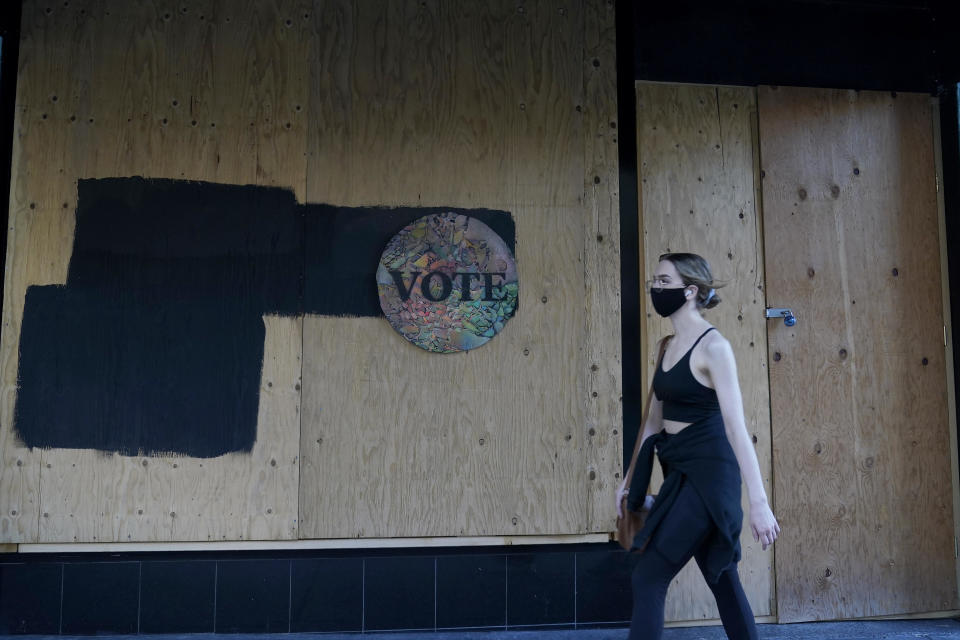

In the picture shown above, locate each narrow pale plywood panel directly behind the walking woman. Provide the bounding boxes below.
[630,83,774,620]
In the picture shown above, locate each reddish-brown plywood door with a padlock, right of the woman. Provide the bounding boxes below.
[758,87,957,622]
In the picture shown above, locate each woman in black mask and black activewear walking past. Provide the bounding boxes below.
[617,253,780,640]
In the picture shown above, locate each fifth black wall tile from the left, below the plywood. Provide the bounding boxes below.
[290,558,363,633]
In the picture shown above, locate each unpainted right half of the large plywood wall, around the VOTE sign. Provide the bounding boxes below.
[300,1,620,537]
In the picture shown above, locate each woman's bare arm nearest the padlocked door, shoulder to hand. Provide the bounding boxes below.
[704,335,780,550]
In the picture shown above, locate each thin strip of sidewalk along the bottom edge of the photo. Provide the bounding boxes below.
[11,618,960,640]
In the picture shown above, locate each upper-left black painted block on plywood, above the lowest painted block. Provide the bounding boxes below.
[67,178,303,315]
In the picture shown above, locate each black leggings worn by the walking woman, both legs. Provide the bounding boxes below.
[630,479,757,640]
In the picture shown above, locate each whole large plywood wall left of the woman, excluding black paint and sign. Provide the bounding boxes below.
[0,0,621,543]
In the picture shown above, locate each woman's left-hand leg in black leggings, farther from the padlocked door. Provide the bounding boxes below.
[630,482,713,640]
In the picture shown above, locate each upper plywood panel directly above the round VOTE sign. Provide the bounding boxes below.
[308,0,583,210]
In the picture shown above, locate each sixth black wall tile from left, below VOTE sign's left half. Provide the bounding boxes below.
[364,556,436,631]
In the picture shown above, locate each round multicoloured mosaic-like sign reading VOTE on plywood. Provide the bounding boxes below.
[377,213,519,353]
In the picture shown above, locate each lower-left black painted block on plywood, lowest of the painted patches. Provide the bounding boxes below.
[15,286,265,457]
